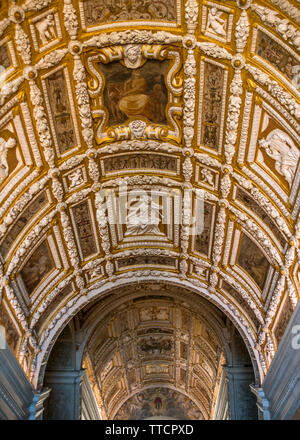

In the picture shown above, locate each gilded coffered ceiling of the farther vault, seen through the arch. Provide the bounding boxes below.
[79,283,230,420]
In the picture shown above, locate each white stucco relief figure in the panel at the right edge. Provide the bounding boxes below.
[259,129,299,185]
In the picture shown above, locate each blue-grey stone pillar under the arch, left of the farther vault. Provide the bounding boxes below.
[44,369,84,420]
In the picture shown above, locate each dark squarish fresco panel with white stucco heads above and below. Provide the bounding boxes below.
[99,57,169,124]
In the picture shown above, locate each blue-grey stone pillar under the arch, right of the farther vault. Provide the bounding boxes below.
[224,365,258,420]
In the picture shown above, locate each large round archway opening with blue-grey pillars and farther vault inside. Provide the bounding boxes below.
[44,281,257,420]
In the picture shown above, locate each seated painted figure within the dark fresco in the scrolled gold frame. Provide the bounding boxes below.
[119,69,153,119]
